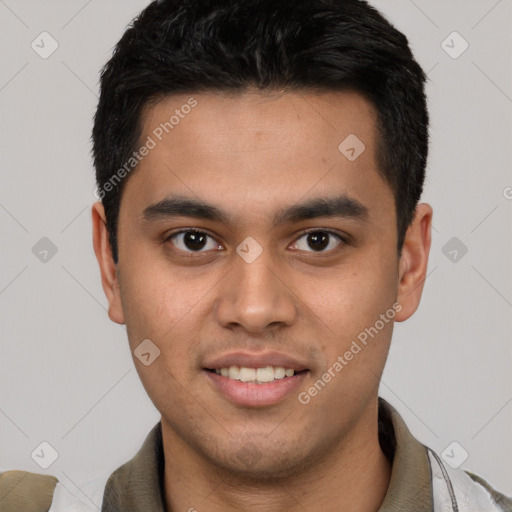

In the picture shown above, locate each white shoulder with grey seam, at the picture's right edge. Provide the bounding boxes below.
[428,449,512,512]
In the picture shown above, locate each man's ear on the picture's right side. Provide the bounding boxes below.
[395,204,432,322]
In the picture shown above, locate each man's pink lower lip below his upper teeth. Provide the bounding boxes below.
[203,370,309,407]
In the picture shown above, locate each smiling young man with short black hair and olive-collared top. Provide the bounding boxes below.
[0,0,512,512]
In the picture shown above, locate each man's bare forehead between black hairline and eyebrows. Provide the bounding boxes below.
[123,92,392,230]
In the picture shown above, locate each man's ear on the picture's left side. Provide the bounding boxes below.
[91,202,125,324]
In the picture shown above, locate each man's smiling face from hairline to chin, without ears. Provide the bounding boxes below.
[97,92,416,478]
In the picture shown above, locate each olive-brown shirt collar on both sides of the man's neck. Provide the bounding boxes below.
[101,398,433,512]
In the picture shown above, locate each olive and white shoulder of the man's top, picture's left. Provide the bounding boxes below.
[0,470,110,512]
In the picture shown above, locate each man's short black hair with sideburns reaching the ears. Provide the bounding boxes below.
[92,0,428,263]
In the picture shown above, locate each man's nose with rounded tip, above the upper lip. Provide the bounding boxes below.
[214,250,297,334]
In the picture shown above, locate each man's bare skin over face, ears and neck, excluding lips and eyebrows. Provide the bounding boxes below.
[92,91,432,512]
